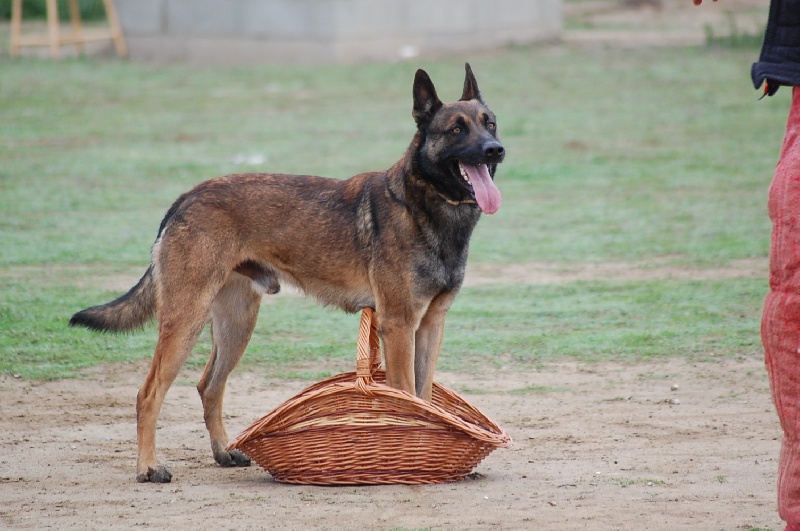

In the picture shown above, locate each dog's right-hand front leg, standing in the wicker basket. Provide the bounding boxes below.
[414,291,456,401]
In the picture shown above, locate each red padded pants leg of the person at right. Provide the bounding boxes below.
[761,87,800,530]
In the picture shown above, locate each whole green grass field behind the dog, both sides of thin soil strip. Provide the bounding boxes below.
[0,30,789,379]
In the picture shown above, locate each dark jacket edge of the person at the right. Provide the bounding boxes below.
[751,0,800,96]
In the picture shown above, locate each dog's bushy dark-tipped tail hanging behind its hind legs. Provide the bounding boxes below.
[69,265,156,332]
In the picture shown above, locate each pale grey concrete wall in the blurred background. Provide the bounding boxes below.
[116,0,562,64]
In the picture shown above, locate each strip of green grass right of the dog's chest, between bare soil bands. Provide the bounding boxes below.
[440,279,765,370]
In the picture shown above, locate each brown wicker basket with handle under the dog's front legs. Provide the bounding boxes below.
[228,308,511,485]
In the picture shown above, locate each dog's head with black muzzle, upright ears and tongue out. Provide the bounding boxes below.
[412,63,505,214]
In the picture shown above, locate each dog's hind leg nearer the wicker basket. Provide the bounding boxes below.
[197,273,261,466]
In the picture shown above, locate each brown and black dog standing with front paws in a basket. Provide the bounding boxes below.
[70,64,505,482]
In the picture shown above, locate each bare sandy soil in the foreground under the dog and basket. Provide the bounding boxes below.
[0,358,780,529]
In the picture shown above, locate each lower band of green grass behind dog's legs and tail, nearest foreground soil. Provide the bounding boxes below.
[0,272,765,380]
